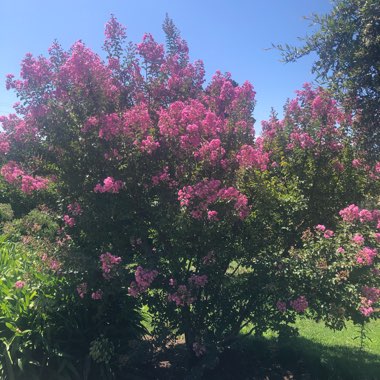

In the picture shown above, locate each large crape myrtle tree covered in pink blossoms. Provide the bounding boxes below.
[0,17,380,372]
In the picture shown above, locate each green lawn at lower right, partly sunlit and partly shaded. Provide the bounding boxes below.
[209,319,380,380]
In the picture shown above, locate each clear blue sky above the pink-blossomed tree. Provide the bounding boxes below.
[0,0,331,129]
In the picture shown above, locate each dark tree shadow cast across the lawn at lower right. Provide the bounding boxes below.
[204,337,380,380]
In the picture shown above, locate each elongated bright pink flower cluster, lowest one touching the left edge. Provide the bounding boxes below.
[1,161,49,194]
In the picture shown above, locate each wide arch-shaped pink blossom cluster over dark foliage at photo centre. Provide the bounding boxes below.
[178,179,249,220]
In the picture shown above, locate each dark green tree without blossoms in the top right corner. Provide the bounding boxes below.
[277,0,380,160]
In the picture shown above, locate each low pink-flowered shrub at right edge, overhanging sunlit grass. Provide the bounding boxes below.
[282,204,380,328]
